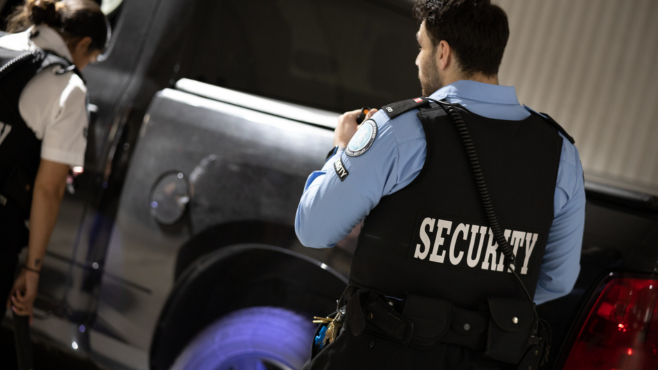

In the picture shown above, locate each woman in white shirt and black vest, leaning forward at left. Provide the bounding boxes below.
[0,0,110,320]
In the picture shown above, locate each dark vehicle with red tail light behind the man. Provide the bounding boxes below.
[5,0,657,369]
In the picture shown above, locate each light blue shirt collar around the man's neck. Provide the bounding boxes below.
[430,80,520,105]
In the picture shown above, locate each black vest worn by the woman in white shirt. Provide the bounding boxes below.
[0,48,84,218]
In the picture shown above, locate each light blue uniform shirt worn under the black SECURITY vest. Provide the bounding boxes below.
[296,80,586,304]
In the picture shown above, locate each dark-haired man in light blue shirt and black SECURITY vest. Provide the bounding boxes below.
[295,0,585,370]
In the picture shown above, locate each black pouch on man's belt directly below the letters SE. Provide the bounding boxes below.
[403,293,452,348]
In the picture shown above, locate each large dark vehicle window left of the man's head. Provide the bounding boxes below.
[179,0,420,112]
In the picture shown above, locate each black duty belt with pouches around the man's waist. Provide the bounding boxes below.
[346,289,537,364]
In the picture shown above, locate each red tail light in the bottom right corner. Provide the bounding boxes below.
[564,276,658,370]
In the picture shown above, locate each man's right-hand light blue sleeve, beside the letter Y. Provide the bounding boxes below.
[534,136,586,304]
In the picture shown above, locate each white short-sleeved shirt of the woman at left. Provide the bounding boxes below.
[0,25,88,167]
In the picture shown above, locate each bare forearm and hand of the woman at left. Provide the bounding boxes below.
[8,159,69,316]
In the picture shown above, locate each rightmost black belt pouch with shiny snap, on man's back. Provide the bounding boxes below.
[484,298,536,364]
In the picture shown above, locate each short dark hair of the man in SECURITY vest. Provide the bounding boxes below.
[413,0,509,77]
